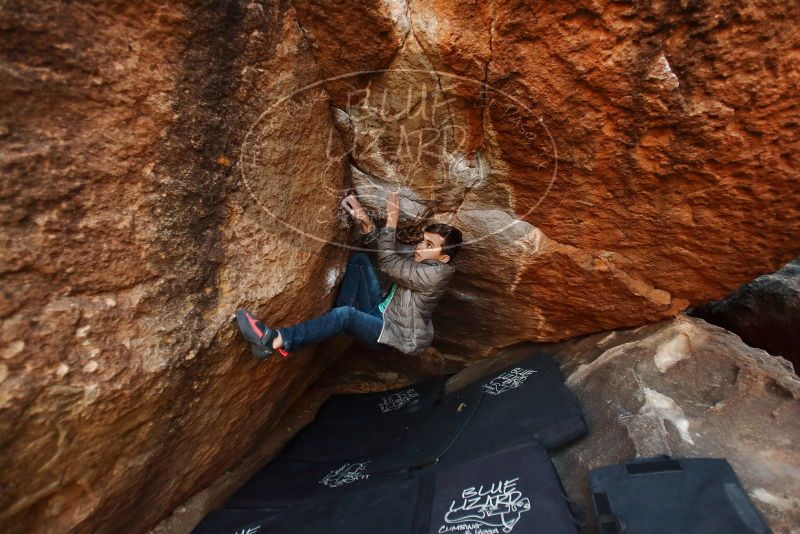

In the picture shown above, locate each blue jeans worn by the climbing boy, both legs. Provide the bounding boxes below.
[278,252,383,352]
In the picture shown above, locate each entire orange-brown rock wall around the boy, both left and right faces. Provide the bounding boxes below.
[0,0,800,532]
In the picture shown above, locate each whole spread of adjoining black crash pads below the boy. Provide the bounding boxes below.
[198,354,587,534]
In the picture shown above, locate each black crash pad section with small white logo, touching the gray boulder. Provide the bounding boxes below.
[372,353,588,473]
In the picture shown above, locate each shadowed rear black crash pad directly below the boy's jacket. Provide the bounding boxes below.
[316,376,447,424]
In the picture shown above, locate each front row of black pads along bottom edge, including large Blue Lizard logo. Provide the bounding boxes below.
[195,443,577,534]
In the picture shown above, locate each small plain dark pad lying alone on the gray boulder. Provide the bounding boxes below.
[589,457,771,534]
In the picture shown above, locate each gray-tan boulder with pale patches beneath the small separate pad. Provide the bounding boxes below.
[549,315,800,532]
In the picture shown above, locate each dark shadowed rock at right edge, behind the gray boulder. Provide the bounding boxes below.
[691,259,800,371]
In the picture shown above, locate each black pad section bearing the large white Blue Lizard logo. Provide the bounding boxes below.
[425,443,578,534]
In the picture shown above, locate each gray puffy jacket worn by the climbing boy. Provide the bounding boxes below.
[363,225,456,355]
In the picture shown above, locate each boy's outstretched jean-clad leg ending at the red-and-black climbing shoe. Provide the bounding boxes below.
[278,306,383,352]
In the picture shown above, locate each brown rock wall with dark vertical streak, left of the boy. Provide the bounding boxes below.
[0,2,344,532]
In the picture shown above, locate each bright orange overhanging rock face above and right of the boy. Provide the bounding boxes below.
[297,0,800,355]
